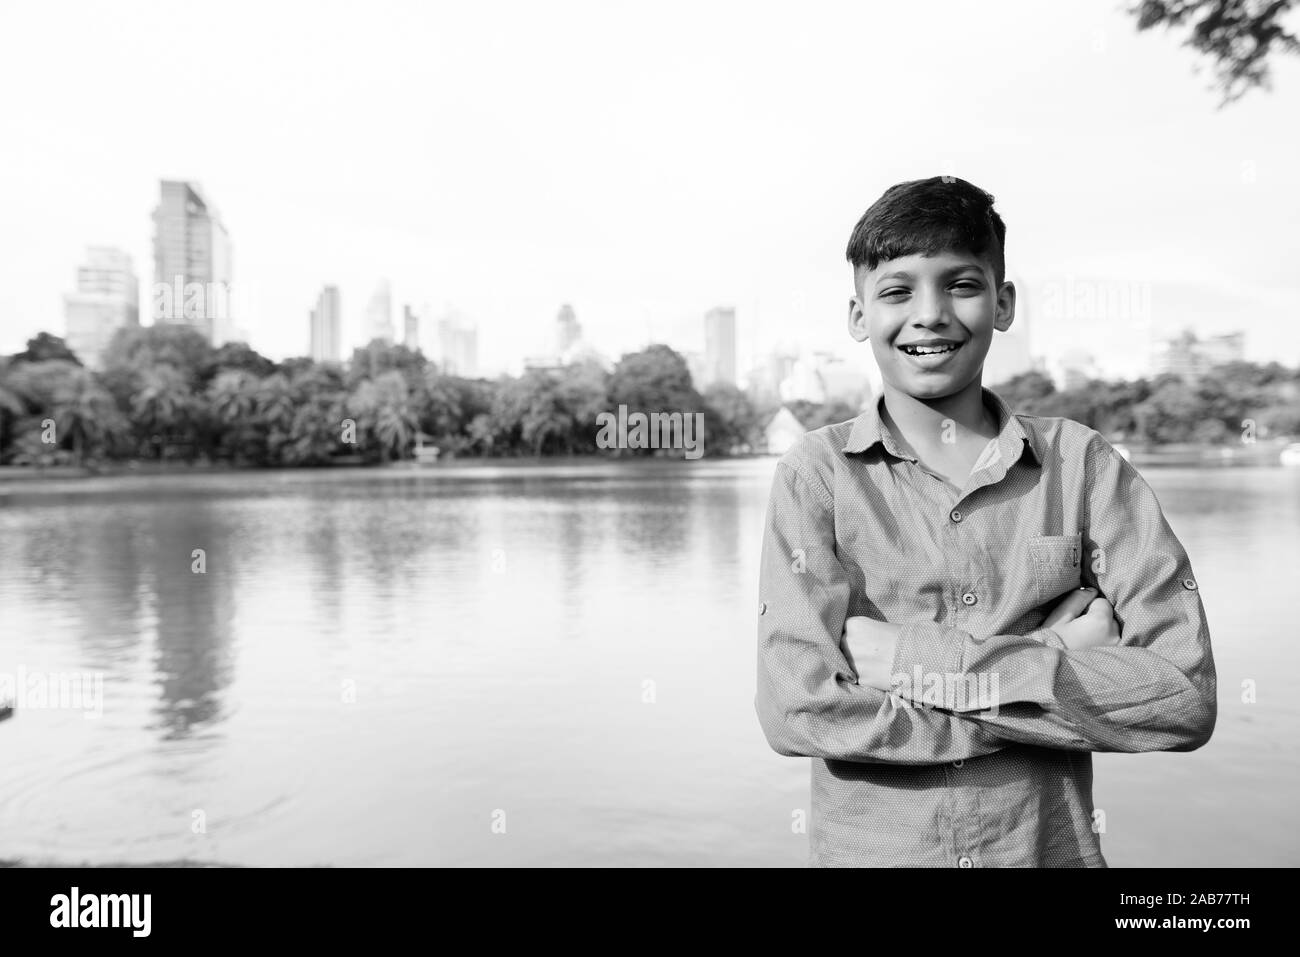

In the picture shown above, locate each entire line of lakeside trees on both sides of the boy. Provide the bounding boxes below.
[0,325,1300,465]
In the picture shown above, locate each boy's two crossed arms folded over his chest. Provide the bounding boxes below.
[755,443,1216,765]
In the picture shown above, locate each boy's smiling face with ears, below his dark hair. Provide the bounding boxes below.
[849,250,1015,399]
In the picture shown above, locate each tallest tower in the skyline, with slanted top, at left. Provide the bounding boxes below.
[151,179,234,346]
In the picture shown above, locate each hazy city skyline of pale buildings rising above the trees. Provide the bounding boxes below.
[38,179,1247,390]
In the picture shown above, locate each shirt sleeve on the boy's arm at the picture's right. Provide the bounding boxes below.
[894,434,1217,752]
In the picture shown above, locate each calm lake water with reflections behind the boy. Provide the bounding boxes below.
[0,459,1300,866]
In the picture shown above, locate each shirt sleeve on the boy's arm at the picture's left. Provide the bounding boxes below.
[755,456,1006,765]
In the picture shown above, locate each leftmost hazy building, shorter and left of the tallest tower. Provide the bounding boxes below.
[64,246,140,368]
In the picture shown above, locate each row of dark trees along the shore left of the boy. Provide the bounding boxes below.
[0,325,785,465]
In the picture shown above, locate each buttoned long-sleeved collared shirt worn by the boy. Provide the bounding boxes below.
[755,389,1217,867]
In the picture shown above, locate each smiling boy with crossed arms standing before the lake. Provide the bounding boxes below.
[755,177,1217,867]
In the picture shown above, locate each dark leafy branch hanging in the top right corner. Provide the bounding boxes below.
[1128,0,1300,107]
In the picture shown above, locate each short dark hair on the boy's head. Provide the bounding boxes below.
[846,176,1006,286]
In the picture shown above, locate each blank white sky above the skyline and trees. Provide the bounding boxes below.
[0,0,1300,372]
